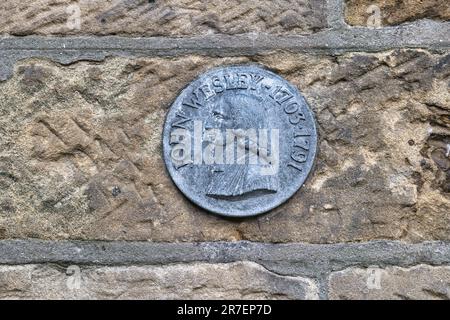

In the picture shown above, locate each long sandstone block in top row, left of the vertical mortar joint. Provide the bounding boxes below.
[0,0,326,36]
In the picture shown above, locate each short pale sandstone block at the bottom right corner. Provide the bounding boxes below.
[329,265,450,300]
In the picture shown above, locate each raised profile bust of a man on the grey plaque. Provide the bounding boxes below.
[205,94,278,197]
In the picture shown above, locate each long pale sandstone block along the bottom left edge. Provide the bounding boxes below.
[0,262,318,299]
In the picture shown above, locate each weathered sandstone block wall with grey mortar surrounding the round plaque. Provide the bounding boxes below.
[0,0,450,299]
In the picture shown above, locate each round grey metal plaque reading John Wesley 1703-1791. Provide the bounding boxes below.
[163,65,317,217]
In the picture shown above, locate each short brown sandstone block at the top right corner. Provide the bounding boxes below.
[345,0,450,26]
